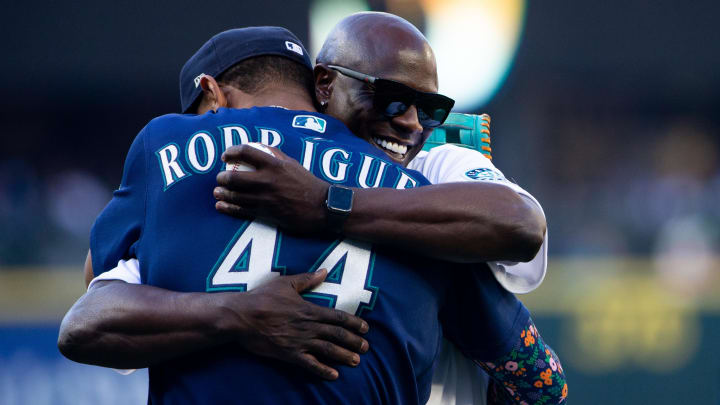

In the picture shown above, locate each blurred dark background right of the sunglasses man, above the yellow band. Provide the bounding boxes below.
[483,0,720,255]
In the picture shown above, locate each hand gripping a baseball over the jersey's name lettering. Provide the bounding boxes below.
[213,145,330,233]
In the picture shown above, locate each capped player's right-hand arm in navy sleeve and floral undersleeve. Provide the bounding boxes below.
[440,271,567,404]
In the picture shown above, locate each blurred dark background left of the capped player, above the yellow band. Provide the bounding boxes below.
[0,0,309,266]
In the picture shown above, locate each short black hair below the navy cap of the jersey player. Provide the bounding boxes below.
[217,55,315,99]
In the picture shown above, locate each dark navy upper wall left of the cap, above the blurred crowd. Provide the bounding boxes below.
[0,0,309,180]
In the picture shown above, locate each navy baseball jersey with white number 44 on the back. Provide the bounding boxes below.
[91,107,528,404]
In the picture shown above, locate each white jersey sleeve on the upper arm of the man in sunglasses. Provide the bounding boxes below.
[408,144,548,294]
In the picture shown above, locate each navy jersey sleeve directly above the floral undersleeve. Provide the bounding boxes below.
[440,262,530,361]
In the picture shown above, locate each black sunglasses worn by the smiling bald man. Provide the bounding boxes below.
[328,65,455,128]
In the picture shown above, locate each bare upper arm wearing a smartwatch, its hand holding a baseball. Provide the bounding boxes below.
[214,146,545,262]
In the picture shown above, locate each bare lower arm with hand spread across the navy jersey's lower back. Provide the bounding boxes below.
[58,254,369,379]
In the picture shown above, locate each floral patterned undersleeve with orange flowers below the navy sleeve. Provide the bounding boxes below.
[476,319,567,405]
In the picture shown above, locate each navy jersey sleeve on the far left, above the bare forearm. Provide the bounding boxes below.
[90,128,147,276]
